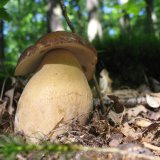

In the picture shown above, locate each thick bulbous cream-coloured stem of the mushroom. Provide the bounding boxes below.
[15,49,92,142]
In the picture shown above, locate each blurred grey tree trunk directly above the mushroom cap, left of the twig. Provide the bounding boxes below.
[47,0,64,32]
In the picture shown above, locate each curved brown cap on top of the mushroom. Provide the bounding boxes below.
[15,31,97,80]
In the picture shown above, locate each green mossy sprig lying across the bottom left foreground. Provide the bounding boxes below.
[0,135,80,160]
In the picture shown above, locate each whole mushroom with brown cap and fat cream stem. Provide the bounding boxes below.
[15,31,97,143]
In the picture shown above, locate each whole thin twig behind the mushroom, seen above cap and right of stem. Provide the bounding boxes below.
[59,0,105,114]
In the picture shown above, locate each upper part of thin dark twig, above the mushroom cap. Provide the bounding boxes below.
[59,0,75,33]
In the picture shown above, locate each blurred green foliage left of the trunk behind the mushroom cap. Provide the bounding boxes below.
[4,0,47,68]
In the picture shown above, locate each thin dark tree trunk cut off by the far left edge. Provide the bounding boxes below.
[0,21,4,66]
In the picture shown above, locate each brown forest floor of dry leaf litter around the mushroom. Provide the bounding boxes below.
[0,77,160,160]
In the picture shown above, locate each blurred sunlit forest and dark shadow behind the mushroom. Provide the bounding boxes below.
[0,0,160,87]
